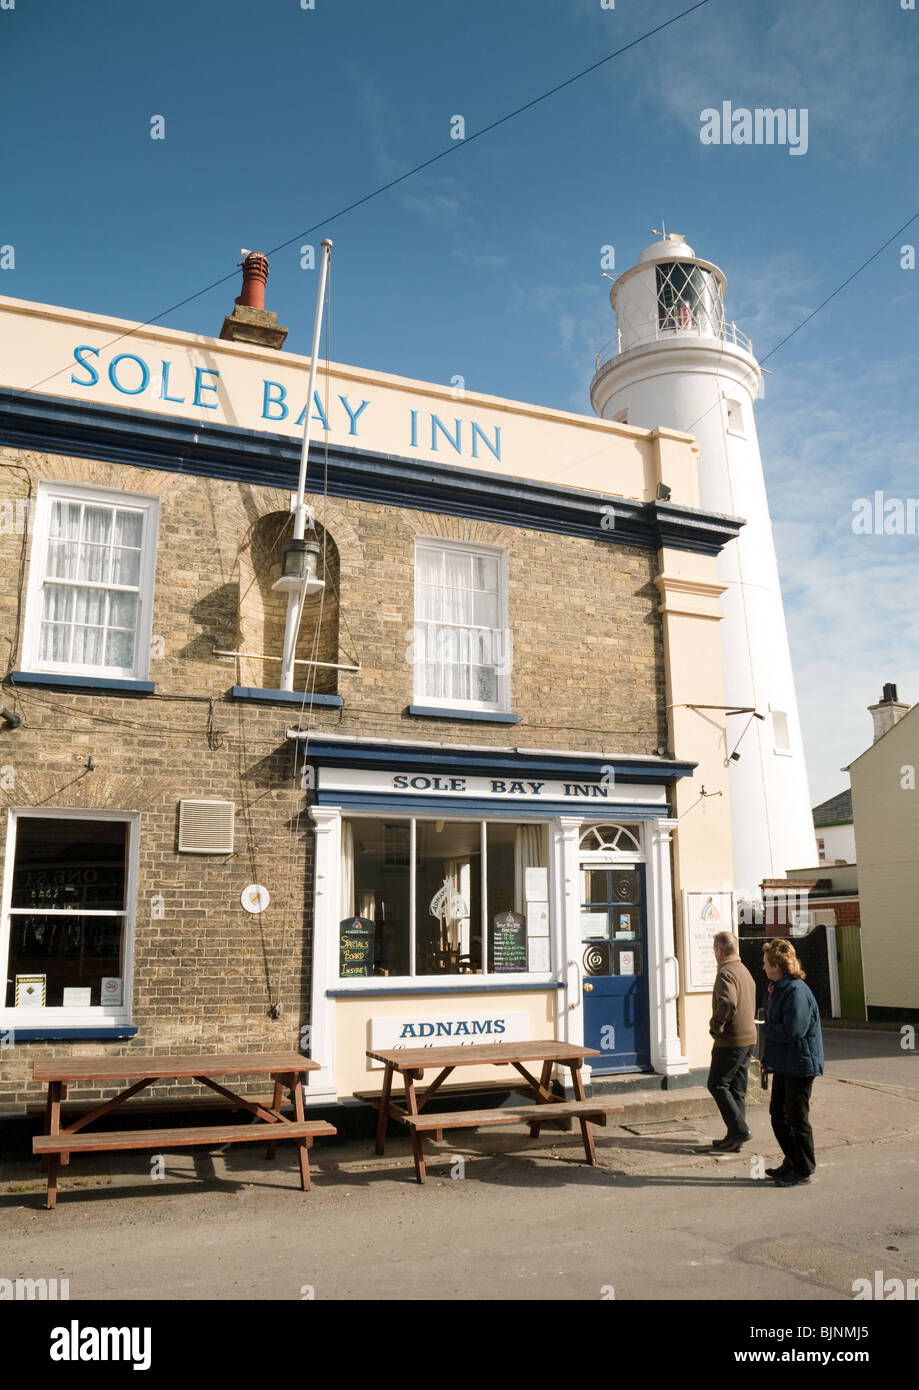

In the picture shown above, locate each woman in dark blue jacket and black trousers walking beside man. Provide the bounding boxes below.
[763,938,823,1187]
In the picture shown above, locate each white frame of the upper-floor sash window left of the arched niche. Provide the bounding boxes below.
[21,482,160,681]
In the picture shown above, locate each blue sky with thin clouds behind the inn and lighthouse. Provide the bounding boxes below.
[0,0,919,802]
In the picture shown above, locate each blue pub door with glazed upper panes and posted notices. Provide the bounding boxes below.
[581,862,651,1076]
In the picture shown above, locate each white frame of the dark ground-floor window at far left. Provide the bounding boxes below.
[0,806,140,1038]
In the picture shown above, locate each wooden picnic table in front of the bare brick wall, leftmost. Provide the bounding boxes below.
[32,1052,336,1211]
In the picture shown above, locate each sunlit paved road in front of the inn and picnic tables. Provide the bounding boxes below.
[0,1034,919,1301]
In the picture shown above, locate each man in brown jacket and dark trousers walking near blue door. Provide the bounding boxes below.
[708,931,756,1154]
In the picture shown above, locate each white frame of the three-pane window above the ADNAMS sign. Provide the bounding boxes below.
[332,808,553,994]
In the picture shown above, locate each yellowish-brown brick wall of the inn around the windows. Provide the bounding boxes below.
[0,449,666,1109]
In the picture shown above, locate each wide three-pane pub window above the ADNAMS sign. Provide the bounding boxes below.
[339,817,551,979]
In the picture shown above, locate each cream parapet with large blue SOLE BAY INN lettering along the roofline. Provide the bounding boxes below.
[0,296,698,506]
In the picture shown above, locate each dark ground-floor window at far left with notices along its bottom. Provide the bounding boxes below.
[3,815,131,1012]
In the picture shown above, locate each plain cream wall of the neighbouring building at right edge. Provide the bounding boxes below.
[849,706,919,1020]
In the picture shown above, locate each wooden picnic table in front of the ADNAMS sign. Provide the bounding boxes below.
[367,1038,621,1183]
